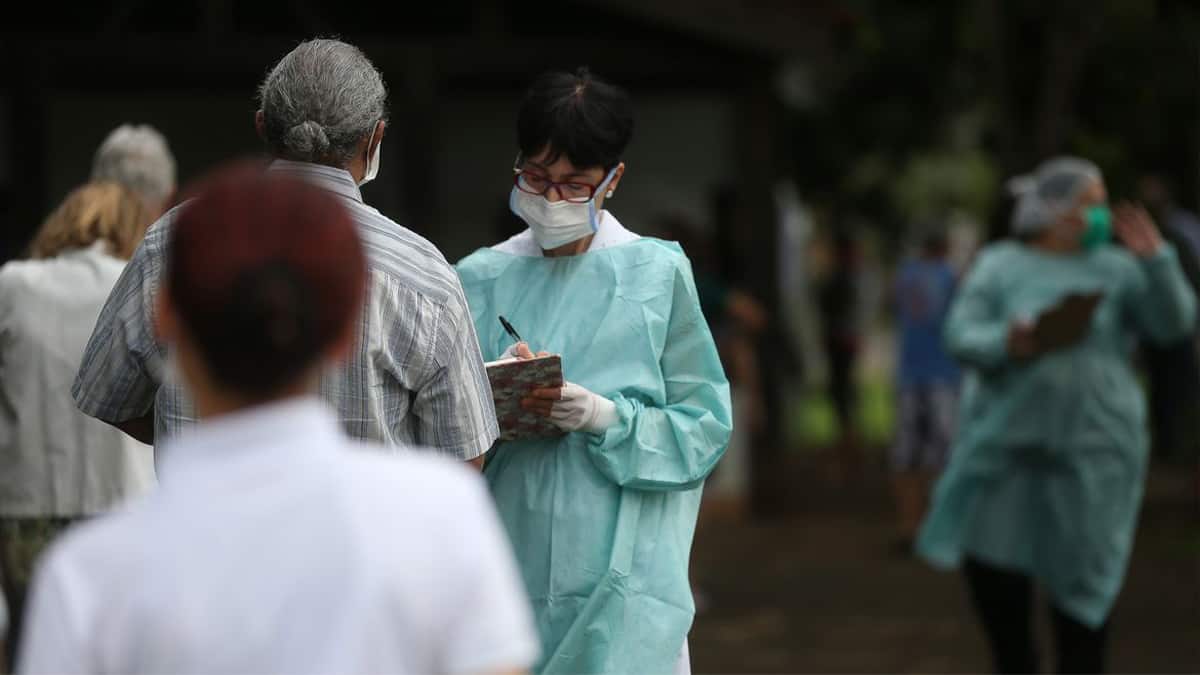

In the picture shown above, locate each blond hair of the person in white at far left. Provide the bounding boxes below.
[29,183,155,259]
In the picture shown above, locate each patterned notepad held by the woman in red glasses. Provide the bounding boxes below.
[484,354,563,441]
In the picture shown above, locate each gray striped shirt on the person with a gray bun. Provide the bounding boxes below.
[72,161,499,459]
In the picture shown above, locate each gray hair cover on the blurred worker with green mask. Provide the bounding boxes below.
[1008,157,1104,237]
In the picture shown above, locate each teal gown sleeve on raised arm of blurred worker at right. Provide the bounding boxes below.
[1126,243,1196,344]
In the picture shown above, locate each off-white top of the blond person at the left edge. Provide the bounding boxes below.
[0,241,154,516]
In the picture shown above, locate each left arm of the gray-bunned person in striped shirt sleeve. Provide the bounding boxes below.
[71,211,174,442]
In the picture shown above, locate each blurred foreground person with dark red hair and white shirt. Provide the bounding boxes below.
[18,168,538,673]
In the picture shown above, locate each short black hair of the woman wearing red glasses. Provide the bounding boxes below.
[517,67,634,169]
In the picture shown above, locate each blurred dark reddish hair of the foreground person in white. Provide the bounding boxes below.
[166,168,366,399]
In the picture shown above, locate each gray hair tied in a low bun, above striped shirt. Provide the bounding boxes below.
[258,40,388,167]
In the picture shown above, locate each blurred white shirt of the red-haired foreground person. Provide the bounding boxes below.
[18,399,539,674]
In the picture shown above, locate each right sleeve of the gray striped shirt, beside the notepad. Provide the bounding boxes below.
[412,281,500,460]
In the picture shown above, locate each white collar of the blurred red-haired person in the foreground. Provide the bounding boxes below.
[160,396,343,484]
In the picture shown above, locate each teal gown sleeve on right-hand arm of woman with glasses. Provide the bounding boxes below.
[588,254,733,490]
